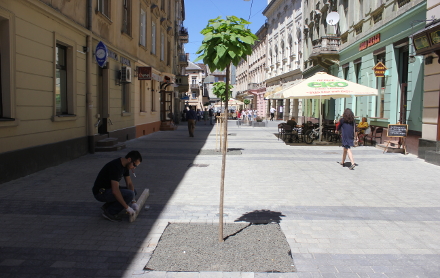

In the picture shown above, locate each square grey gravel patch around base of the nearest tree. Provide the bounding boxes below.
[146,223,296,272]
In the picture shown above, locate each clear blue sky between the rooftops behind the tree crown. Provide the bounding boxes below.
[183,0,267,62]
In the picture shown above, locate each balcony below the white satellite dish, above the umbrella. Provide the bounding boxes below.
[310,36,341,68]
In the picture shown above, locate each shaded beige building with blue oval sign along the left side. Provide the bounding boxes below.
[0,0,184,182]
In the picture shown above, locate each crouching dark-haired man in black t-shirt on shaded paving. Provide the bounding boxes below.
[92,151,142,222]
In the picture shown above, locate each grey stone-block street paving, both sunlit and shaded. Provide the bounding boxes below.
[0,122,440,278]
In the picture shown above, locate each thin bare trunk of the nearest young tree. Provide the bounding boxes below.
[218,65,229,242]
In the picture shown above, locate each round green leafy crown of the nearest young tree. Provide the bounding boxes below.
[195,16,258,71]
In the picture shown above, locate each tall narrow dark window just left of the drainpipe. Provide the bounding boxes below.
[55,44,69,115]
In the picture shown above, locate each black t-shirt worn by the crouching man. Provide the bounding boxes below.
[92,158,130,195]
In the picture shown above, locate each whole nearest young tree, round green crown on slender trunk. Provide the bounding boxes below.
[195,16,258,242]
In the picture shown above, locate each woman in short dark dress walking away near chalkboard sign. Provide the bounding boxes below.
[338,108,356,170]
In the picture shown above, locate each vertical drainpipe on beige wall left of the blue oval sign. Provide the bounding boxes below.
[86,0,95,154]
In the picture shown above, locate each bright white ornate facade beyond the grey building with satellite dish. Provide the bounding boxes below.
[263,0,303,120]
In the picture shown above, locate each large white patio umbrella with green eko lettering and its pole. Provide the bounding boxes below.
[279,72,378,141]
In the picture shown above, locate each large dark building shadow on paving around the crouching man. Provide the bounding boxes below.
[0,123,215,277]
